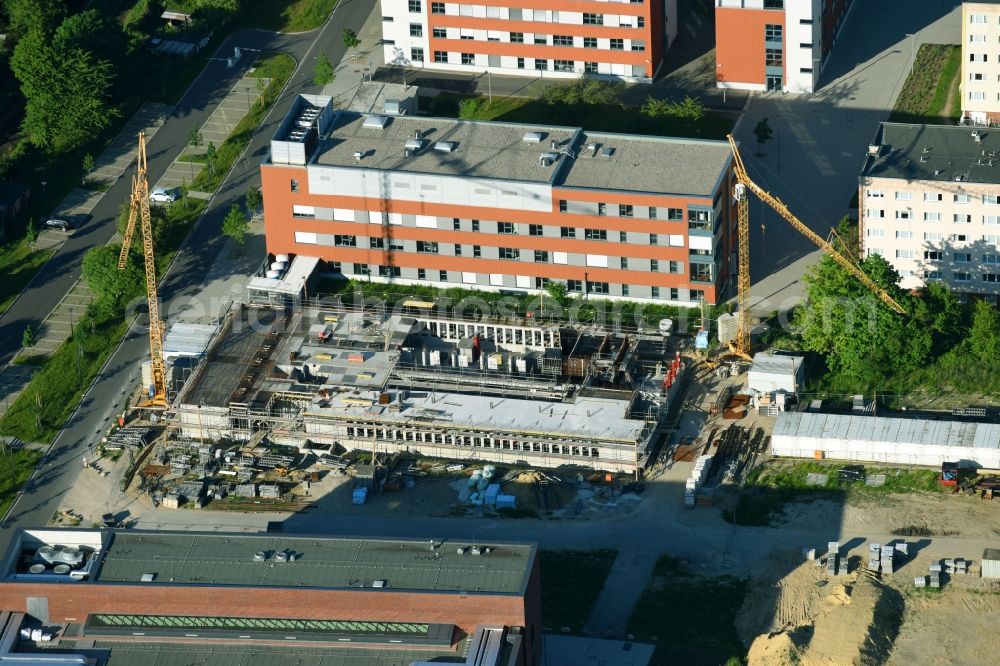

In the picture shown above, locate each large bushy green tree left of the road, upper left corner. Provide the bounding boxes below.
[10,29,119,152]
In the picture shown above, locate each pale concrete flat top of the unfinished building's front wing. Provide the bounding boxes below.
[305,391,646,443]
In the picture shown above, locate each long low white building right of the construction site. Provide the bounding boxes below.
[771,412,1000,468]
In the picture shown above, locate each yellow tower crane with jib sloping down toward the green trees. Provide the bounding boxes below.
[726,134,906,359]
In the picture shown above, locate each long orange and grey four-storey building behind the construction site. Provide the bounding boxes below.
[261,96,735,305]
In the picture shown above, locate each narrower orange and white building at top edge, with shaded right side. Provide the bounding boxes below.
[715,0,853,93]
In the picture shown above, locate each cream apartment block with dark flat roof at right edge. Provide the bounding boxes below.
[858,123,1000,299]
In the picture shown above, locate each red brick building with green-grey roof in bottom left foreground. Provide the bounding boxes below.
[0,530,541,666]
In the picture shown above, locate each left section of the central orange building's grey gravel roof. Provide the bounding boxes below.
[314,112,580,183]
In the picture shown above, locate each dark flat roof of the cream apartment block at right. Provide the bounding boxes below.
[862,123,1000,184]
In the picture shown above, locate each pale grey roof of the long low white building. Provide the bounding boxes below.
[773,412,1000,449]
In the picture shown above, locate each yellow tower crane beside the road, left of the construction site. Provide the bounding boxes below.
[118,132,168,409]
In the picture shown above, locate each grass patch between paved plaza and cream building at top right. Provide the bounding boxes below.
[889,44,962,124]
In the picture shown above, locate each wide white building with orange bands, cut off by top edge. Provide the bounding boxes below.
[381,0,677,81]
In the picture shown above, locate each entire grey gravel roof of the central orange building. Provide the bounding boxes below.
[315,112,731,196]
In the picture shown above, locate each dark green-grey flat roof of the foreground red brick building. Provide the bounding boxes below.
[95,530,535,594]
